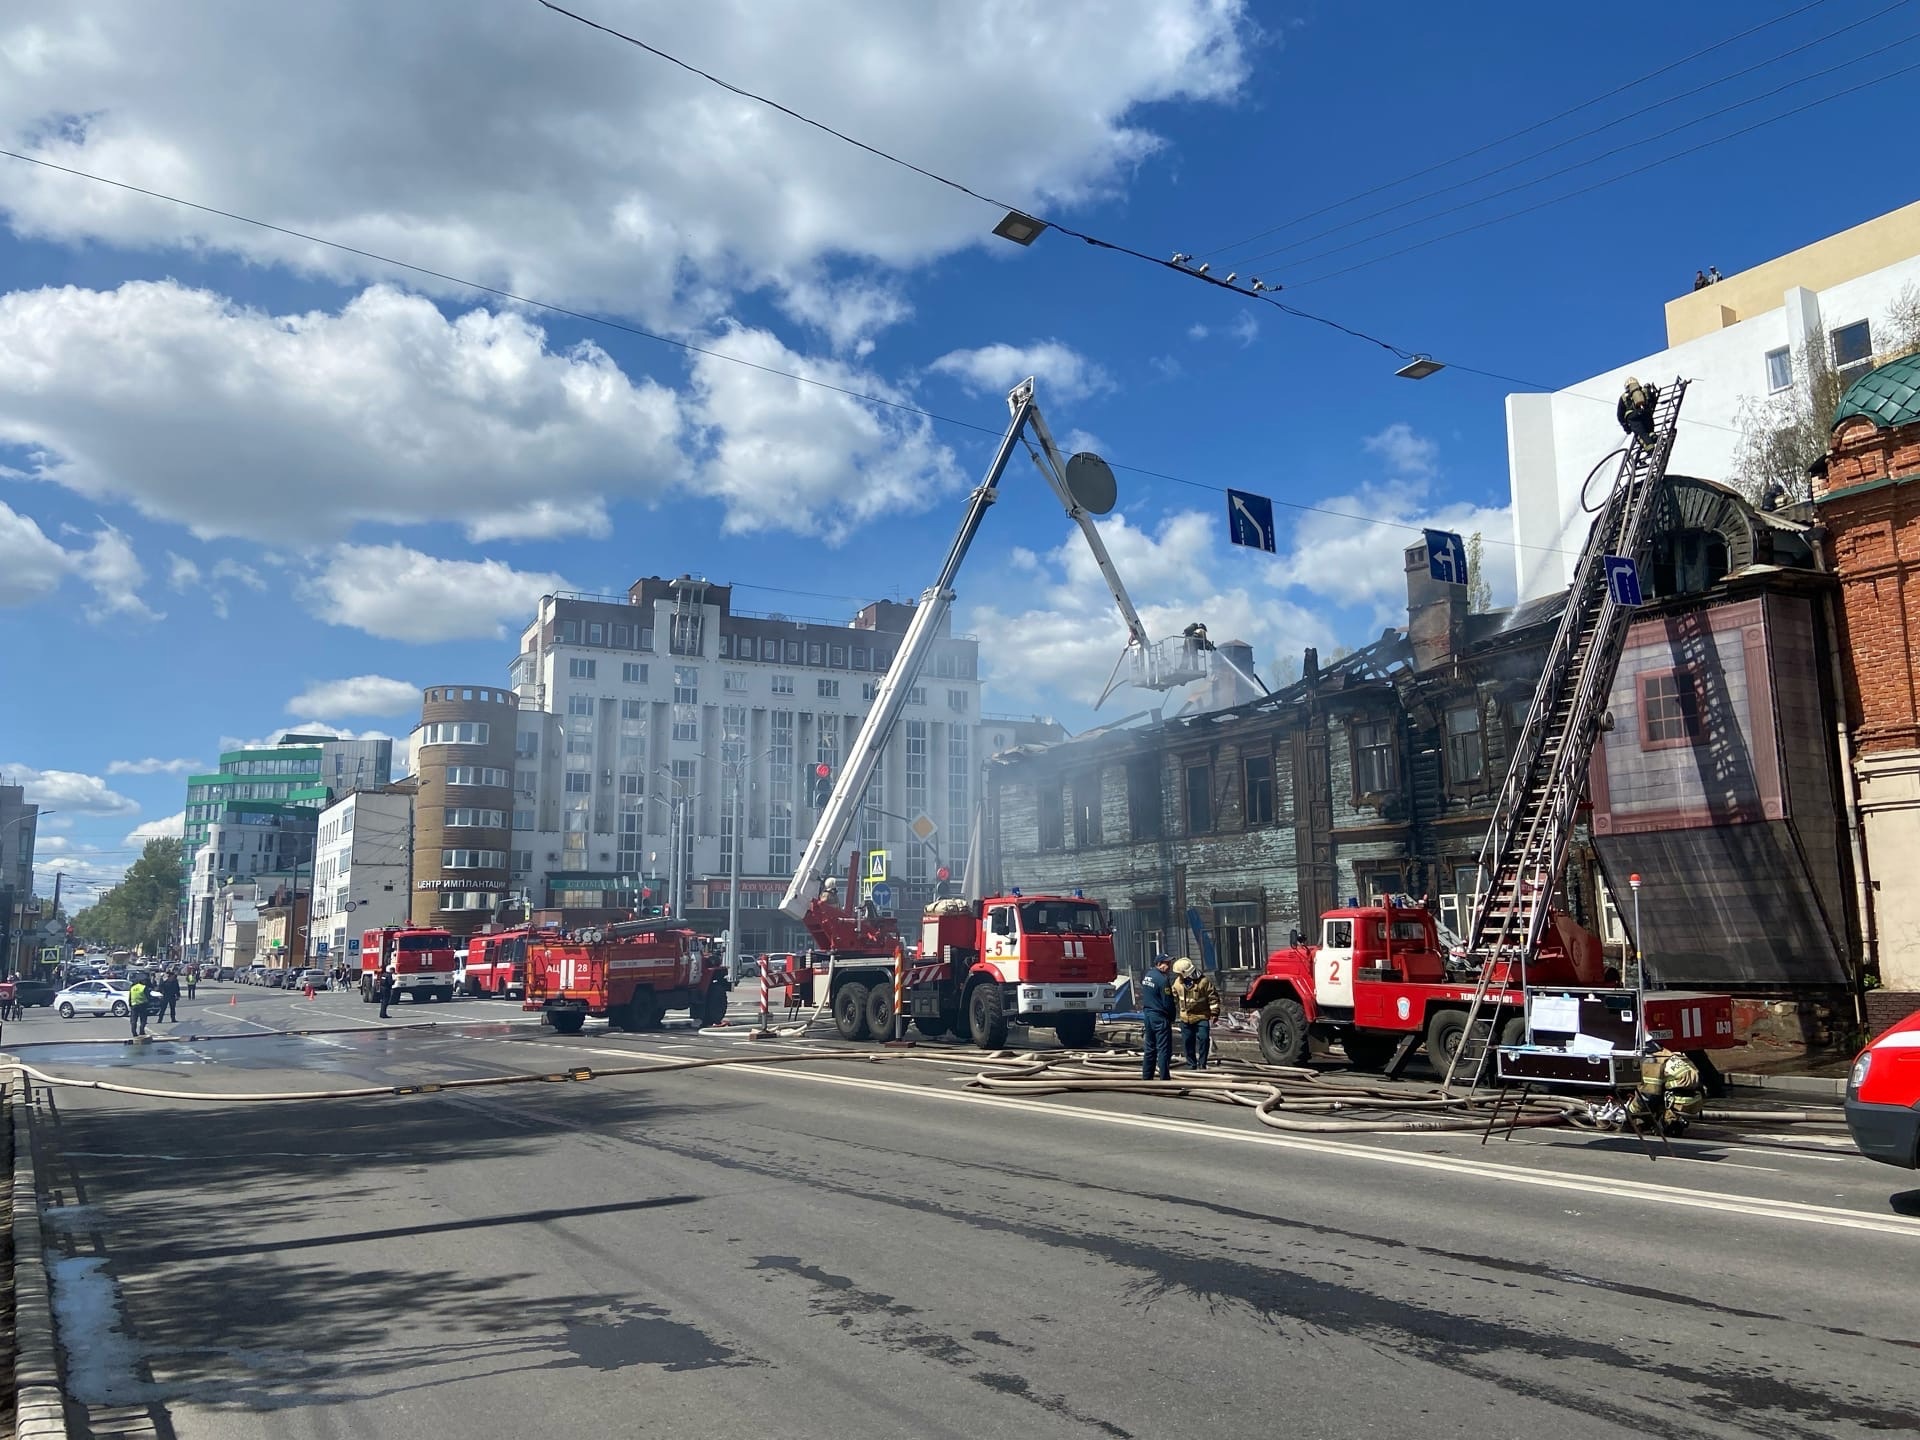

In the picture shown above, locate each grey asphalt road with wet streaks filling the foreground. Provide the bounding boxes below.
[8,987,1920,1440]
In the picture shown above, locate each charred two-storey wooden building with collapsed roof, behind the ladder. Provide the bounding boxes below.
[985,478,1847,987]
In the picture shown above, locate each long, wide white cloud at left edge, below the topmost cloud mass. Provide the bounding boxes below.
[0,280,685,545]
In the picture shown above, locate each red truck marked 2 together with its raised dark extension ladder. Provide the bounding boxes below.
[1240,380,1734,1087]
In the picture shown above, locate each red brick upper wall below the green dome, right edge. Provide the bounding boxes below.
[1814,419,1920,755]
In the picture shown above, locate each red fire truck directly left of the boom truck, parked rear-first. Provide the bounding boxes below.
[522,918,728,1035]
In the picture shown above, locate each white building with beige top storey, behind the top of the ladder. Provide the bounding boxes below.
[1507,202,1920,601]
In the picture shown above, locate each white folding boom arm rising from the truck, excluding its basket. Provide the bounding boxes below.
[780,376,1152,920]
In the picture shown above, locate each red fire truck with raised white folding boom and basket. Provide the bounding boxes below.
[781,378,1263,1050]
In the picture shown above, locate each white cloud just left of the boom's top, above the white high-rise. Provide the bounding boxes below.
[689,328,960,543]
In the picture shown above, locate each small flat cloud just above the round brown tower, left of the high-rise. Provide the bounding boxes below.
[300,545,568,645]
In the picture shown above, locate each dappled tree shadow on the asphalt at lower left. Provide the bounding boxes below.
[38,1085,724,1409]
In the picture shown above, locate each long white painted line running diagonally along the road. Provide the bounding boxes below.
[718,1068,1920,1238]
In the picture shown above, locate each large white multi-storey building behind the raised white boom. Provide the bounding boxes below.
[511,576,1004,954]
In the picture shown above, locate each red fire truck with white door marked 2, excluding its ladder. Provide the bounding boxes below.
[1240,900,1734,1071]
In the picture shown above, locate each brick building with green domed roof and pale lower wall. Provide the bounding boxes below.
[1814,355,1920,1025]
